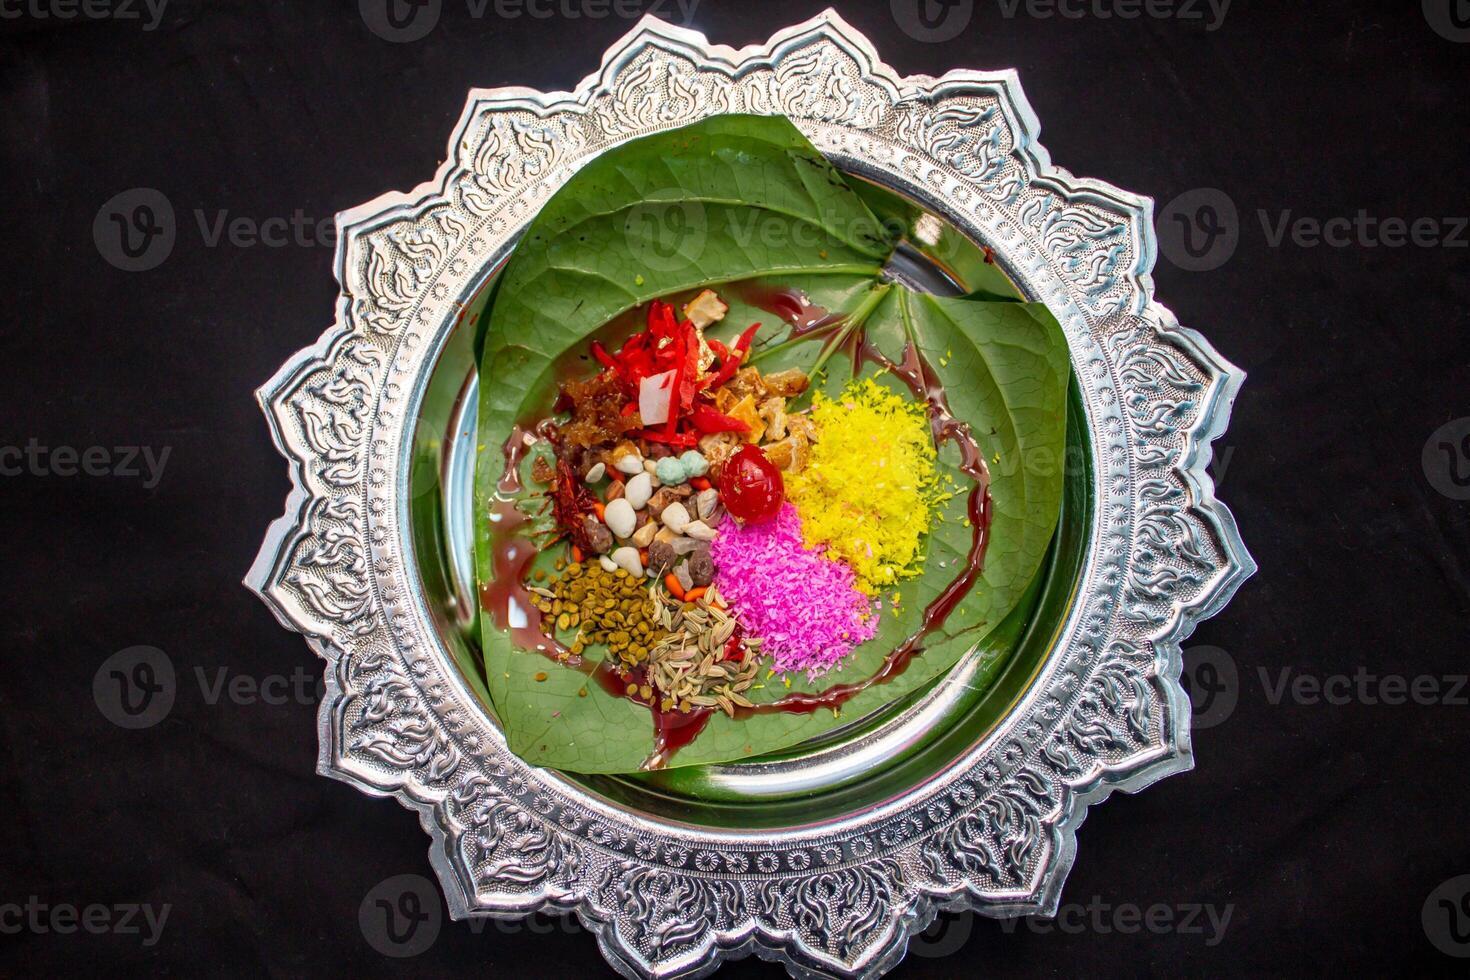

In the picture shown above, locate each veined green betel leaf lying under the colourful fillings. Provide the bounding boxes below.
[476,116,1069,773]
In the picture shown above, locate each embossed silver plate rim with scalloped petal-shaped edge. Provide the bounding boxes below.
[247,12,1254,977]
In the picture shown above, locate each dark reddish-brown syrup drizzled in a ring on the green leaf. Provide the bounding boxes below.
[481,287,992,770]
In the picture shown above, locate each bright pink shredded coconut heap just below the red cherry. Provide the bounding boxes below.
[710,504,878,677]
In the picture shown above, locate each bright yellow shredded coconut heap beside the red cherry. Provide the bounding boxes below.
[786,378,950,595]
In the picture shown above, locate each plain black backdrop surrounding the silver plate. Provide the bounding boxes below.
[0,0,1470,977]
